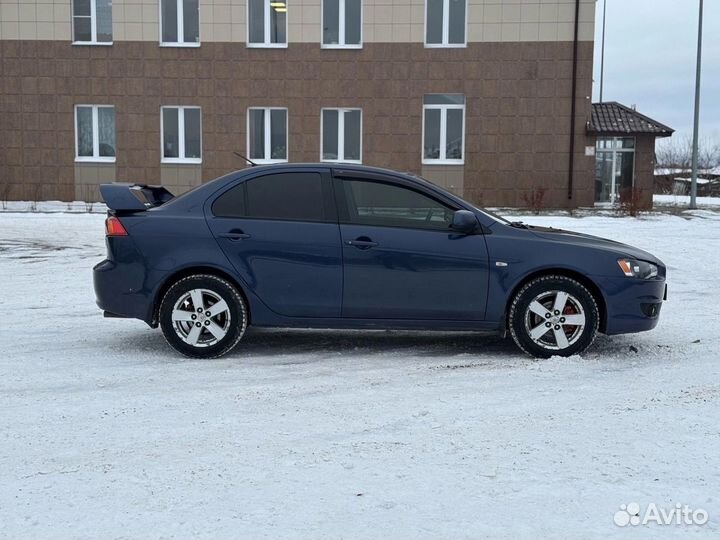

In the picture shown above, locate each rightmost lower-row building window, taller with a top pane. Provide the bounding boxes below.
[423,94,465,164]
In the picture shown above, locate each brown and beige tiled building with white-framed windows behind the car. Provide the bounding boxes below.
[0,0,595,207]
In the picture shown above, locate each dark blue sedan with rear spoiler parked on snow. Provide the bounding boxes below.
[94,163,666,358]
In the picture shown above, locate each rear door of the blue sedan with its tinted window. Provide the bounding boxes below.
[208,168,342,317]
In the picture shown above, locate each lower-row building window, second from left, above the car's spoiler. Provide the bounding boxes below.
[160,107,202,163]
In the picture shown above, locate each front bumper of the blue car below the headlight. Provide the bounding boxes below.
[595,277,666,335]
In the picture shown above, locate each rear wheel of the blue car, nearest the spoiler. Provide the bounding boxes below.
[159,274,247,358]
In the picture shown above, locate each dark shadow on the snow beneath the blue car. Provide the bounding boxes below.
[108,328,668,369]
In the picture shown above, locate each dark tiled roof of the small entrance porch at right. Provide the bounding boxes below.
[587,101,675,137]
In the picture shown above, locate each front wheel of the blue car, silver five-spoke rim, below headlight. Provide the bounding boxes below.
[508,276,600,358]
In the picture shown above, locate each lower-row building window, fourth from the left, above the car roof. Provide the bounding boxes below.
[320,109,362,163]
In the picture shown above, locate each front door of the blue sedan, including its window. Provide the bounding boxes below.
[335,178,488,320]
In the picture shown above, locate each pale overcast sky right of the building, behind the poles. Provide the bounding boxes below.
[593,0,720,142]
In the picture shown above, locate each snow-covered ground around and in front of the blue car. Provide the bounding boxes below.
[0,211,720,540]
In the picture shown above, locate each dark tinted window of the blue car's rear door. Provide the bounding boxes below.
[213,172,326,221]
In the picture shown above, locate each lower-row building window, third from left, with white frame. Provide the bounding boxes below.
[247,107,288,163]
